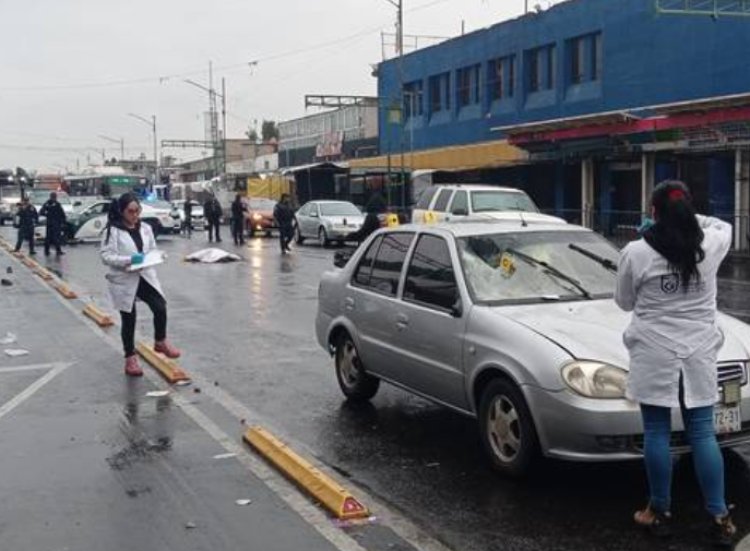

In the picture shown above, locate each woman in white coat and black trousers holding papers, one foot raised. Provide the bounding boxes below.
[101,193,180,377]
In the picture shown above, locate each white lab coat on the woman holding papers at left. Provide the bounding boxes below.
[100,223,164,312]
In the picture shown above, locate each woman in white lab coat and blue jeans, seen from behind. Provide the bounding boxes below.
[615,181,736,545]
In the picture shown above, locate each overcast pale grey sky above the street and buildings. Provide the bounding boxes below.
[0,0,549,172]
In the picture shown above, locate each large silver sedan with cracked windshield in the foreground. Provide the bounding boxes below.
[316,221,750,475]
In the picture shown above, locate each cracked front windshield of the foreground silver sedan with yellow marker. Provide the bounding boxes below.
[457,231,619,303]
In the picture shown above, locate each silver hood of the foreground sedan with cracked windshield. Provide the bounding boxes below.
[496,299,750,368]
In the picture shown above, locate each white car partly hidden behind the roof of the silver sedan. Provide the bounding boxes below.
[412,184,565,224]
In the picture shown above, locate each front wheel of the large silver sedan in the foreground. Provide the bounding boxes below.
[479,379,539,476]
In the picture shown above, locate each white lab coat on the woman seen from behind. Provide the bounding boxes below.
[615,216,732,408]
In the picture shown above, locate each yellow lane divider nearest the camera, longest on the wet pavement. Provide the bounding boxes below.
[244,425,370,520]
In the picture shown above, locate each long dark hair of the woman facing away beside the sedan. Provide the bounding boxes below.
[643,180,706,291]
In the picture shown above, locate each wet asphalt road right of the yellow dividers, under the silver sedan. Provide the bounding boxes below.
[8,225,750,551]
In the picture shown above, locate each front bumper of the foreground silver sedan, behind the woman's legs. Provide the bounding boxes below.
[524,385,750,461]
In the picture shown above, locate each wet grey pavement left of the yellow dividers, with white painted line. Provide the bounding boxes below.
[0,251,346,551]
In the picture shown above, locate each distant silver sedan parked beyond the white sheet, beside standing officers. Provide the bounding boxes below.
[295,201,365,247]
